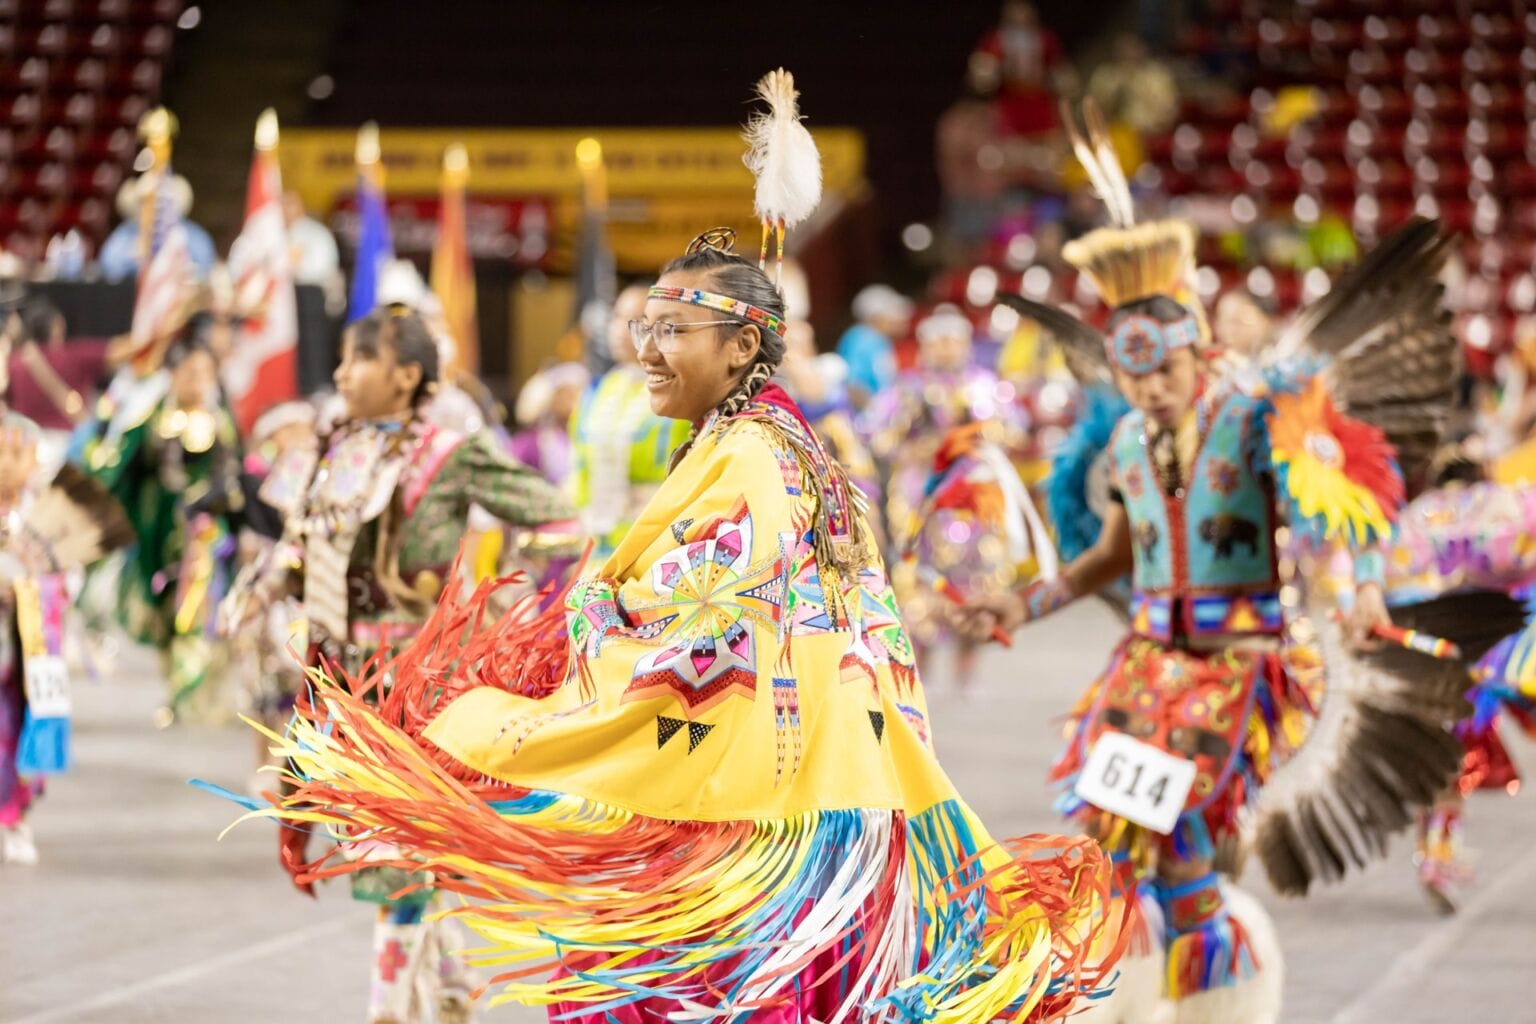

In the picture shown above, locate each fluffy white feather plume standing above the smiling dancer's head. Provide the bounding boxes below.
[742,68,822,227]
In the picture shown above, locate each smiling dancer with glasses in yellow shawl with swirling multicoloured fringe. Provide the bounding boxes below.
[227,72,1114,1024]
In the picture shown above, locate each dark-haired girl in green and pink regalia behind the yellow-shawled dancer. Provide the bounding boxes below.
[223,306,574,1024]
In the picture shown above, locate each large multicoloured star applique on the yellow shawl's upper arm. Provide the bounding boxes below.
[624,500,788,720]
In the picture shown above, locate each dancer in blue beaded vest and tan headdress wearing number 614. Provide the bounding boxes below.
[958,196,1453,1024]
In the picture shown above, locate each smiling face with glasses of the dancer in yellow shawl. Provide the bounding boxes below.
[639,272,760,422]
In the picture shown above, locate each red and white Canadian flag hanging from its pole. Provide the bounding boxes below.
[224,111,298,433]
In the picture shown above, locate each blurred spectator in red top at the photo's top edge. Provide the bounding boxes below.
[971,0,1072,137]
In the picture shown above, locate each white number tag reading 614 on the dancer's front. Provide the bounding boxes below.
[1074,732,1195,835]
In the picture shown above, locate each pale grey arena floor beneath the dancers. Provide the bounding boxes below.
[0,595,1536,1024]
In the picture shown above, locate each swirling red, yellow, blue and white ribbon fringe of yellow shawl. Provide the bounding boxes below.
[249,583,1129,1024]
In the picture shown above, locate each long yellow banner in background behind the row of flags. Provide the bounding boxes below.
[280,127,865,273]
